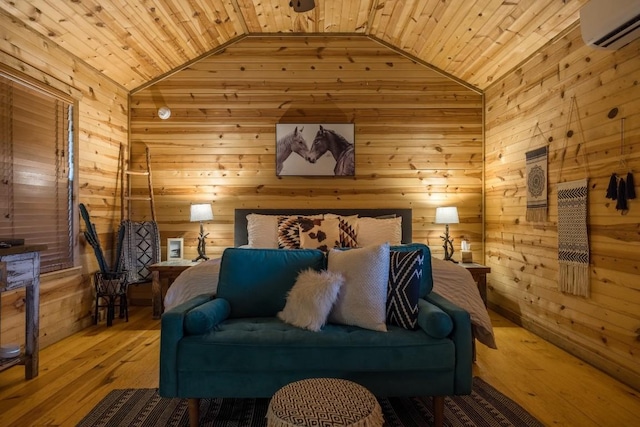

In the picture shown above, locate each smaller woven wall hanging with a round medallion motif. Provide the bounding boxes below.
[526,145,547,222]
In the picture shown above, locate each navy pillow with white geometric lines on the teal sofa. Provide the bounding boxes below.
[387,249,424,329]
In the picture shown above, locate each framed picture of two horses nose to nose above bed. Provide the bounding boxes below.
[276,123,356,176]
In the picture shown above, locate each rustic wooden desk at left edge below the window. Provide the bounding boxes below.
[0,245,47,380]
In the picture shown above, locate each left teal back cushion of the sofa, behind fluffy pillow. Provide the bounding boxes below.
[217,248,325,318]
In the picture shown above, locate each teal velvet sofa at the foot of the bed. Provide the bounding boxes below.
[159,244,472,425]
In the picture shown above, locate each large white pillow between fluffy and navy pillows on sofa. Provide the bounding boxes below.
[327,243,389,332]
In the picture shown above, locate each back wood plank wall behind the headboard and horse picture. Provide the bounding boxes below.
[131,36,483,264]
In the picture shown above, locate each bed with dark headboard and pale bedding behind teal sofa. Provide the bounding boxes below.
[164,209,497,348]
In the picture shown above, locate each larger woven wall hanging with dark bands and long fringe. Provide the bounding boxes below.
[558,179,589,297]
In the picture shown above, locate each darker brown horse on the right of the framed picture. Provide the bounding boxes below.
[307,125,356,176]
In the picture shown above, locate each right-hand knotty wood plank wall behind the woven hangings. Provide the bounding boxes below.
[485,28,640,389]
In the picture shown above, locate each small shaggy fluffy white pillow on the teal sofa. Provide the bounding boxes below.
[278,269,344,332]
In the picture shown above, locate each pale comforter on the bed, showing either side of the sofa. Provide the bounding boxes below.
[164,258,497,348]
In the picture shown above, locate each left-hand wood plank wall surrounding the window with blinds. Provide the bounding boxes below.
[0,13,128,347]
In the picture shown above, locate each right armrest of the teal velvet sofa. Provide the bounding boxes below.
[424,292,473,394]
